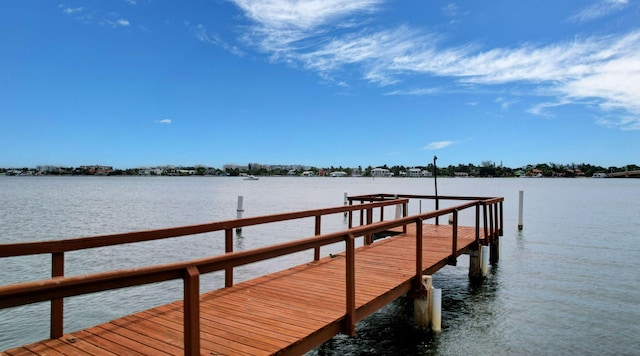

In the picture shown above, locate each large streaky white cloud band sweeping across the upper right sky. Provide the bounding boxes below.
[228,0,640,128]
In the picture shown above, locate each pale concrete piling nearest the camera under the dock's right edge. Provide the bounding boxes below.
[413,276,442,333]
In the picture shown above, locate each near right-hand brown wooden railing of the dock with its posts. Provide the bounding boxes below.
[0,198,504,354]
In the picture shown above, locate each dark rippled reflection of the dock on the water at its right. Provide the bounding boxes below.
[308,256,501,356]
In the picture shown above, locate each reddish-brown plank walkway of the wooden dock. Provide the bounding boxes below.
[0,195,501,355]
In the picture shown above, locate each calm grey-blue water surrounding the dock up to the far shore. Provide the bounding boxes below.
[0,176,640,355]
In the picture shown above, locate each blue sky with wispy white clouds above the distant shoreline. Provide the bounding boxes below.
[0,0,640,168]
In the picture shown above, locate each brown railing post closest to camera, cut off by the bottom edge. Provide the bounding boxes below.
[183,266,200,355]
